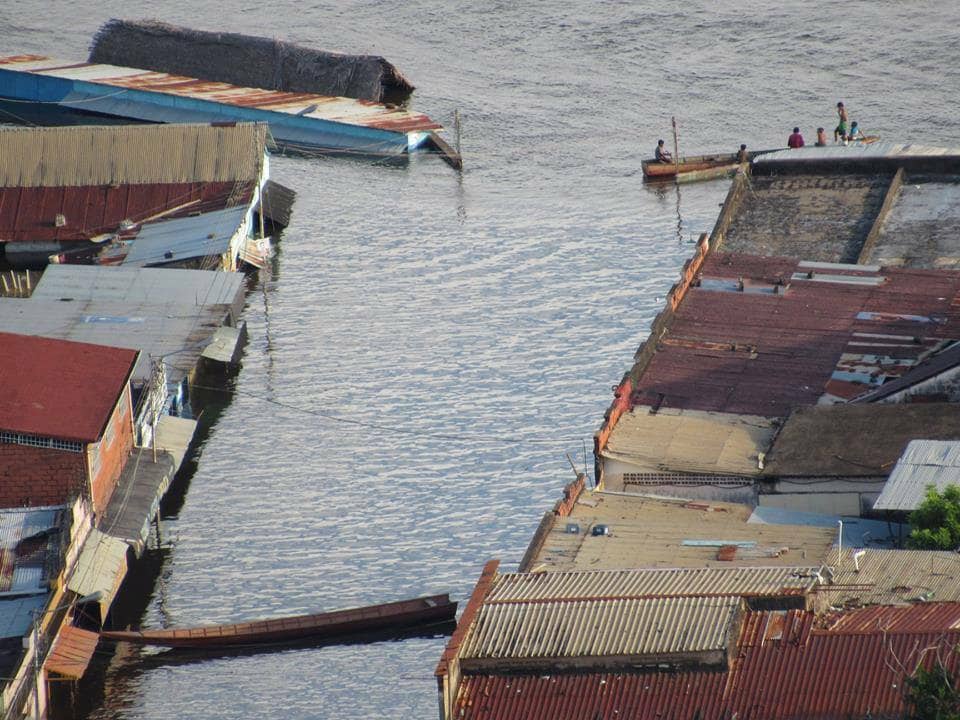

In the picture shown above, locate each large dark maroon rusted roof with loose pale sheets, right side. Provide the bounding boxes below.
[631,253,960,417]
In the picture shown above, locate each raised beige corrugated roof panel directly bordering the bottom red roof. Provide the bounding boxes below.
[460,596,742,669]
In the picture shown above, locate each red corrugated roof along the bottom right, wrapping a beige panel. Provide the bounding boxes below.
[454,603,960,720]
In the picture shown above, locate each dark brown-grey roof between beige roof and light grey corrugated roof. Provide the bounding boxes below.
[764,403,960,477]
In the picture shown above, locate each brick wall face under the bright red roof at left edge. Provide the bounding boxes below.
[0,443,87,507]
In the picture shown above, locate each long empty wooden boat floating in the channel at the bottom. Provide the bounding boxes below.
[100,594,457,649]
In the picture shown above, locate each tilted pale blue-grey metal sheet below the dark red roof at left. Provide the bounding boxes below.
[121,206,248,267]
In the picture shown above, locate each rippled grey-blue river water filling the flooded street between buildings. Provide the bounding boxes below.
[0,0,960,720]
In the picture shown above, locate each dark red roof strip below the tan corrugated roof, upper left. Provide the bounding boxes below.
[0,181,255,243]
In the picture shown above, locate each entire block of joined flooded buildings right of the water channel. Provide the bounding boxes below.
[436,148,960,720]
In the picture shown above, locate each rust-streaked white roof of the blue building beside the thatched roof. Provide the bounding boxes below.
[0,56,439,133]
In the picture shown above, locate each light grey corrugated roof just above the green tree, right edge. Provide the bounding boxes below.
[873,440,960,511]
